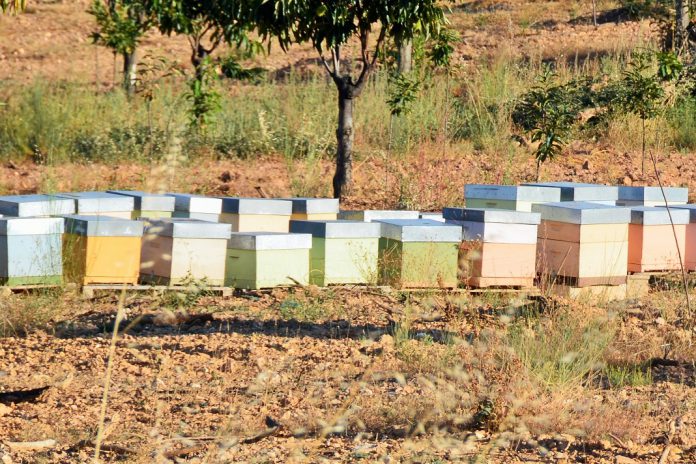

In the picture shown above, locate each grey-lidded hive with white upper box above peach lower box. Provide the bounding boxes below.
[444,208,541,287]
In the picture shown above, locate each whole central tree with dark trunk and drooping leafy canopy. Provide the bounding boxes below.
[252,0,445,198]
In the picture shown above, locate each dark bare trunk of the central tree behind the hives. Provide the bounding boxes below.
[333,83,353,198]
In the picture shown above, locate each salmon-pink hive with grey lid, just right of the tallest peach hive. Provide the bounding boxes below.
[628,206,690,272]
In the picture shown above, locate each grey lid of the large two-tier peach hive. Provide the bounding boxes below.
[532,201,631,224]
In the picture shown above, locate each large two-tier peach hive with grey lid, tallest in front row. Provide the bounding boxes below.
[533,202,631,287]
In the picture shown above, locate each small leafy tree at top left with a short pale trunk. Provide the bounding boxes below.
[88,0,154,97]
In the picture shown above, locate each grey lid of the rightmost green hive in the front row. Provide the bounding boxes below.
[377,219,462,242]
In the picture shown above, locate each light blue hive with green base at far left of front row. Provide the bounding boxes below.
[0,217,63,286]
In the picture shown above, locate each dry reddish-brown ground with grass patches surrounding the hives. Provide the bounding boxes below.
[0,0,696,464]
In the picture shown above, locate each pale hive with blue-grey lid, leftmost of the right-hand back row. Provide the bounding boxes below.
[464,184,561,212]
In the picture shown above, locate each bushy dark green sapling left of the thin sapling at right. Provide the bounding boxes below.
[512,69,591,171]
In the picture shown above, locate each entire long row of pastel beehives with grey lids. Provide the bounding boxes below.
[0,183,696,294]
